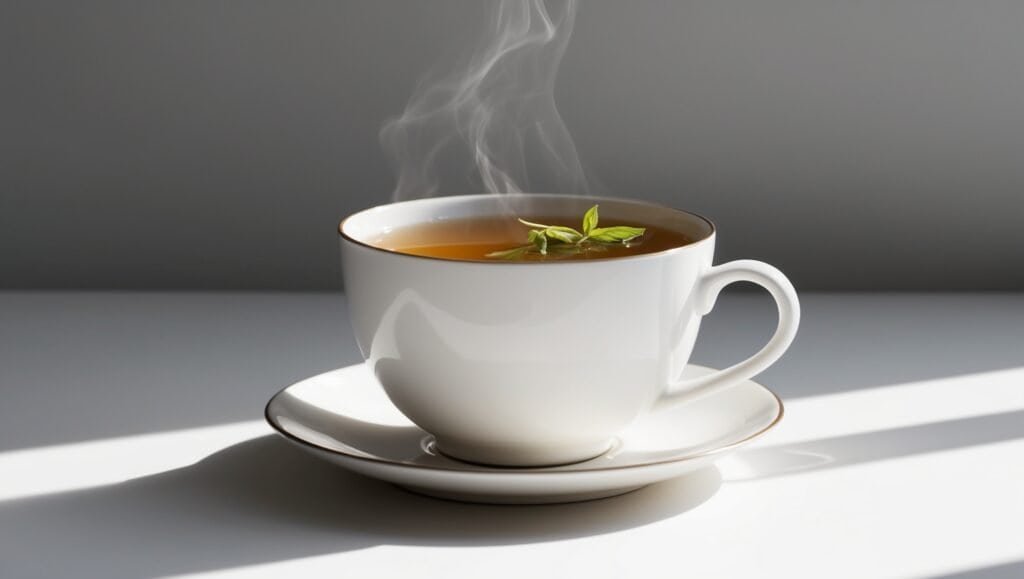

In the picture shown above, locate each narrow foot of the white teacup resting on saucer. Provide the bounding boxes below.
[431,437,615,468]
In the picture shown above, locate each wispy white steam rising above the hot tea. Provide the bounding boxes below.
[381,0,590,201]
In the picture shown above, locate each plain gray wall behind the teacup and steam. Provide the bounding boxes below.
[0,0,1024,289]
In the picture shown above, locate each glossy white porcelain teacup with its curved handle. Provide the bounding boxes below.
[339,195,800,466]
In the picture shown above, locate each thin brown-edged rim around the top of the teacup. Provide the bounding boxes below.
[338,193,718,266]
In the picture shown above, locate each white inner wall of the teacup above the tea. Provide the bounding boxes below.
[339,194,715,249]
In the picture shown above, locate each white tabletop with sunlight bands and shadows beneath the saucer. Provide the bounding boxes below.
[0,292,1024,579]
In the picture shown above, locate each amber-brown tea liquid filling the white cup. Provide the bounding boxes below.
[375,215,693,261]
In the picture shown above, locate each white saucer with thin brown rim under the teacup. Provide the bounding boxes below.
[265,364,782,504]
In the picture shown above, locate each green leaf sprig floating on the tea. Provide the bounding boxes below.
[486,205,647,259]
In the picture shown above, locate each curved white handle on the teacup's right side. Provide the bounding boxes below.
[654,259,800,410]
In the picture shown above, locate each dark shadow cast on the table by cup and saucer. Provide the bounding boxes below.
[0,436,721,579]
